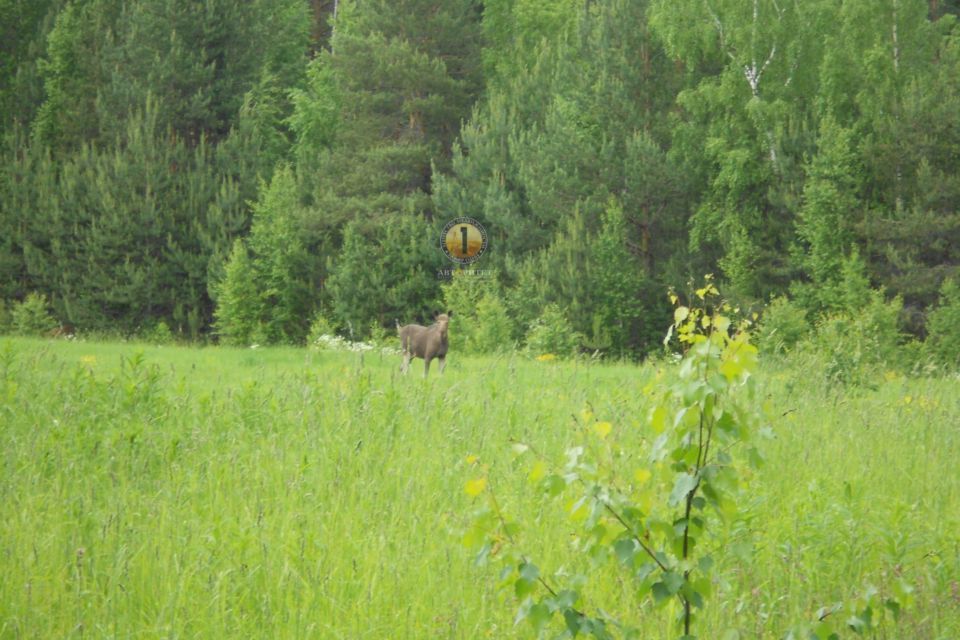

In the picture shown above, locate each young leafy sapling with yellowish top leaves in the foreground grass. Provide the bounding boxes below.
[466,281,762,639]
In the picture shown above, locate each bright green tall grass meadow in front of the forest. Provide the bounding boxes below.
[0,338,960,640]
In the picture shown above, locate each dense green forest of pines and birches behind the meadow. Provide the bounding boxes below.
[0,0,960,356]
